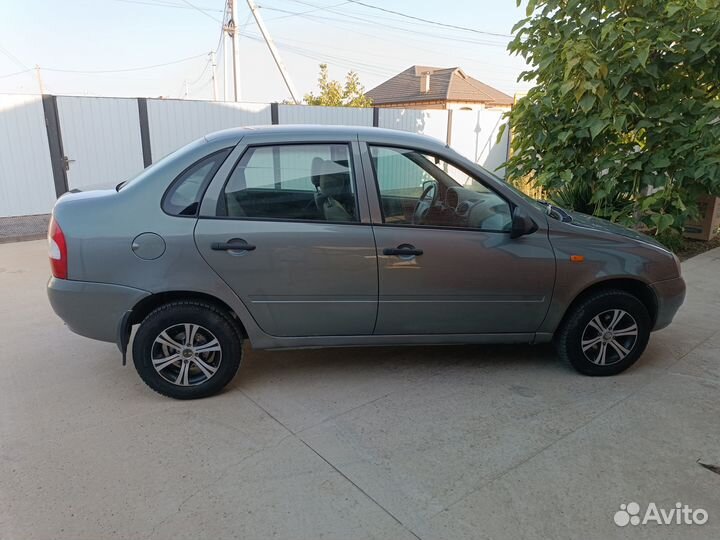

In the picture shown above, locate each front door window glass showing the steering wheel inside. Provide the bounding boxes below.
[370,146,512,232]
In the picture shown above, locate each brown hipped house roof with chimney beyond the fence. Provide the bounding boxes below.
[365,66,513,106]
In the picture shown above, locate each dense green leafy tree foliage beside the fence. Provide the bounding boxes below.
[508,0,720,246]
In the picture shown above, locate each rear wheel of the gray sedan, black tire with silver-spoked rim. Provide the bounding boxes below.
[132,301,242,399]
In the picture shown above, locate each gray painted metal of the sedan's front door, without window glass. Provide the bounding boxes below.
[360,131,555,335]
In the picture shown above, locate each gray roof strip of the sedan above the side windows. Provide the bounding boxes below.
[205,124,447,150]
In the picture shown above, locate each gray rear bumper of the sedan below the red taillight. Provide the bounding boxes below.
[47,278,150,343]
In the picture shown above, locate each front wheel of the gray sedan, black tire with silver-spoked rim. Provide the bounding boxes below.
[555,289,651,376]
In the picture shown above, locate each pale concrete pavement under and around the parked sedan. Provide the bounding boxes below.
[0,241,720,540]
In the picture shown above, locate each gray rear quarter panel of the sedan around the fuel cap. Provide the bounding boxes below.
[53,135,266,344]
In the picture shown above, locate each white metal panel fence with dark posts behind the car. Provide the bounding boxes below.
[0,95,507,218]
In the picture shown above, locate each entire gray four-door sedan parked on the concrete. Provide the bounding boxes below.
[48,126,685,399]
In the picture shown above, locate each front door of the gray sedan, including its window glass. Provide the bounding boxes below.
[369,145,555,334]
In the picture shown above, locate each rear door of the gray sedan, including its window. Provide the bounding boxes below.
[195,138,378,336]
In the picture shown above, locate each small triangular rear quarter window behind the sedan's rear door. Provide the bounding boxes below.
[162,148,230,216]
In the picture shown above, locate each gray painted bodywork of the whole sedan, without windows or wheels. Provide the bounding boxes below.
[48,126,685,348]
